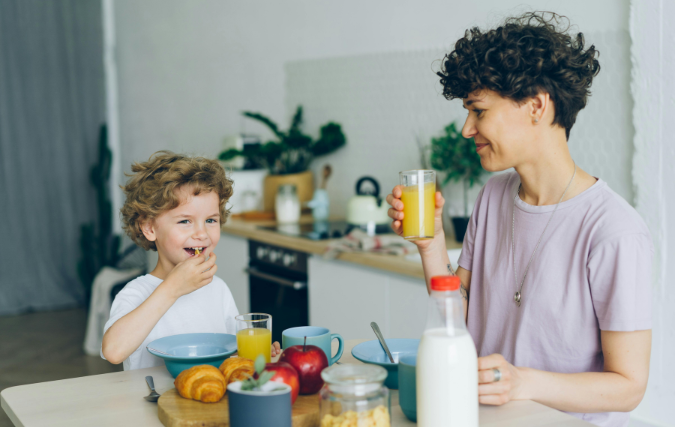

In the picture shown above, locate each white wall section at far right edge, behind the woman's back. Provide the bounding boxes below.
[630,0,675,426]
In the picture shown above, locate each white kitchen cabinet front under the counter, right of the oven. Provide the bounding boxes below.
[308,256,427,339]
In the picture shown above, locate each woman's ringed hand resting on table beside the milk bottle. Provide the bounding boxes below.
[478,353,525,405]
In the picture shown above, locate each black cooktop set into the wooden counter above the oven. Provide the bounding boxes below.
[258,221,393,240]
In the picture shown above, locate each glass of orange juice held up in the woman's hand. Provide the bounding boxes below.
[399,170,436,240]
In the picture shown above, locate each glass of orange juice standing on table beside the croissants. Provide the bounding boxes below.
[234,313,272,363]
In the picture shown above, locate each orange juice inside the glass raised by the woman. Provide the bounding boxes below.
[401,182,436,240]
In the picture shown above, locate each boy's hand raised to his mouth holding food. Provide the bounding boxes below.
[162,253,218,299]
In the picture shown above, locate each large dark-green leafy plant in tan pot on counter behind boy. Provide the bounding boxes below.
[218,106,347,211]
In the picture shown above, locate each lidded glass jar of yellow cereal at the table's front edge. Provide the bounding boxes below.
[320,364,391,427]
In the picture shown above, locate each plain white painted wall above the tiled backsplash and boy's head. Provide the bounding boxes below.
[115,0,628,184]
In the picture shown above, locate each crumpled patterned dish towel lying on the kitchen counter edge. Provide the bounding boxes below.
[323,228,417,259]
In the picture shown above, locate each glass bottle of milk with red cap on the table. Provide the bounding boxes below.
[417,276,478,427]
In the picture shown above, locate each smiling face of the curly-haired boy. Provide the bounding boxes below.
[143,185,220,271]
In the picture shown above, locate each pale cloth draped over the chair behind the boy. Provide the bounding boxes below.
[84,267,143,356]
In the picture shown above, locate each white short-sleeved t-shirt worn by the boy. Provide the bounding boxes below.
[101,274,239,371]
